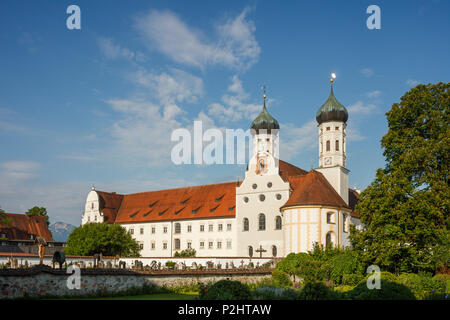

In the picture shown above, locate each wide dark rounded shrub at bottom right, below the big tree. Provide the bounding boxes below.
[346,278,415,300]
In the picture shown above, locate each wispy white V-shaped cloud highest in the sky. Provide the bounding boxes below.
[135,8,261,69]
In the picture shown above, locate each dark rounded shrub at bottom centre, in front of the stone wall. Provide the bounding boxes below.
[200,280,252,300]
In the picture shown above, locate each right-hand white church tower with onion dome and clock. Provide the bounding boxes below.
[316,73,350,204]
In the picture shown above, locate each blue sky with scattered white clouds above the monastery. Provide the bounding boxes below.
[0,0,450,225]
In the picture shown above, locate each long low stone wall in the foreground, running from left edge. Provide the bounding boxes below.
[0,266,271,299]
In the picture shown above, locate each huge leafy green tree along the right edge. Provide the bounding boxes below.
[351,82,450,274]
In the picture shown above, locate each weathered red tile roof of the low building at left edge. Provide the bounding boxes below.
[0,213,53,242]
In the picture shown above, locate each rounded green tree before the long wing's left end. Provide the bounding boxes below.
[64,223,139,257]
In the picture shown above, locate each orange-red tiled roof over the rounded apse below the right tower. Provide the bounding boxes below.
[282,170,350,209]
